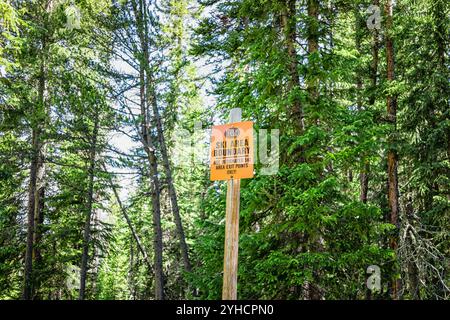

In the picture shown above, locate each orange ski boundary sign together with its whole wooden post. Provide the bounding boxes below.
[210,108,254,300]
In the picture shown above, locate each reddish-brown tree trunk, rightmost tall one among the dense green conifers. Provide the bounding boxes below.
[384,0,400,299]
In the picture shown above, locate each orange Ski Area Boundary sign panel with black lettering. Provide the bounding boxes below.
[210,121,254,180]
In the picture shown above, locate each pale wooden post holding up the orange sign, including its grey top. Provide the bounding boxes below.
[222,108,242,300]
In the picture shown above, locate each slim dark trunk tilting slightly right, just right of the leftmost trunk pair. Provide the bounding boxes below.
[78,111,99,300]
